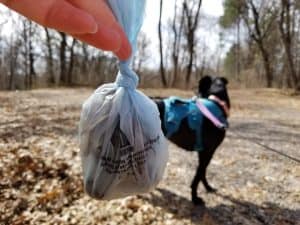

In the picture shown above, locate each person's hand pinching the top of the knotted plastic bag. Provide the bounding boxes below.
[0,0,131,60]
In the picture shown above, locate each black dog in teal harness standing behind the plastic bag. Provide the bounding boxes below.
[154,76,230,205]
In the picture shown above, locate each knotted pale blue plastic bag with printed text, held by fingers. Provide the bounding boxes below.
[79,0,168,200]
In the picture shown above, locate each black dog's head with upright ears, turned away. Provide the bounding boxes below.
[198,76,230,108]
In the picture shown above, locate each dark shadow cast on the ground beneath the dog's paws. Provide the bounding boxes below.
[141,188,300,225]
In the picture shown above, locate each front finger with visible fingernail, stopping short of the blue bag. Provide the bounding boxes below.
[0,0,98,34]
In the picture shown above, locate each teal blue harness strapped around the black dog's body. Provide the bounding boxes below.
[164,96,228,151]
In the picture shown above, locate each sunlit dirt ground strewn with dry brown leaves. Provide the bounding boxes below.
[0,89,300,225]
